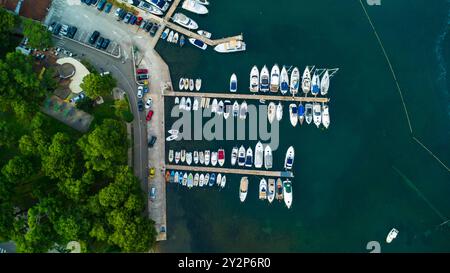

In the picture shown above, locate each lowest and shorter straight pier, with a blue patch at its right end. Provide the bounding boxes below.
[166,165,294,178]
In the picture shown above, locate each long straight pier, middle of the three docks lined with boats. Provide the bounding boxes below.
[163,91,330,103]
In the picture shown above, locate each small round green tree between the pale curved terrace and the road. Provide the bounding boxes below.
[80,73,116,99]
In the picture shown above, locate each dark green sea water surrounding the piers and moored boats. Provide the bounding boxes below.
[157,0,450,252]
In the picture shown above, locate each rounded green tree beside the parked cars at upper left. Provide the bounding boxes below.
[22,19,52,49]
